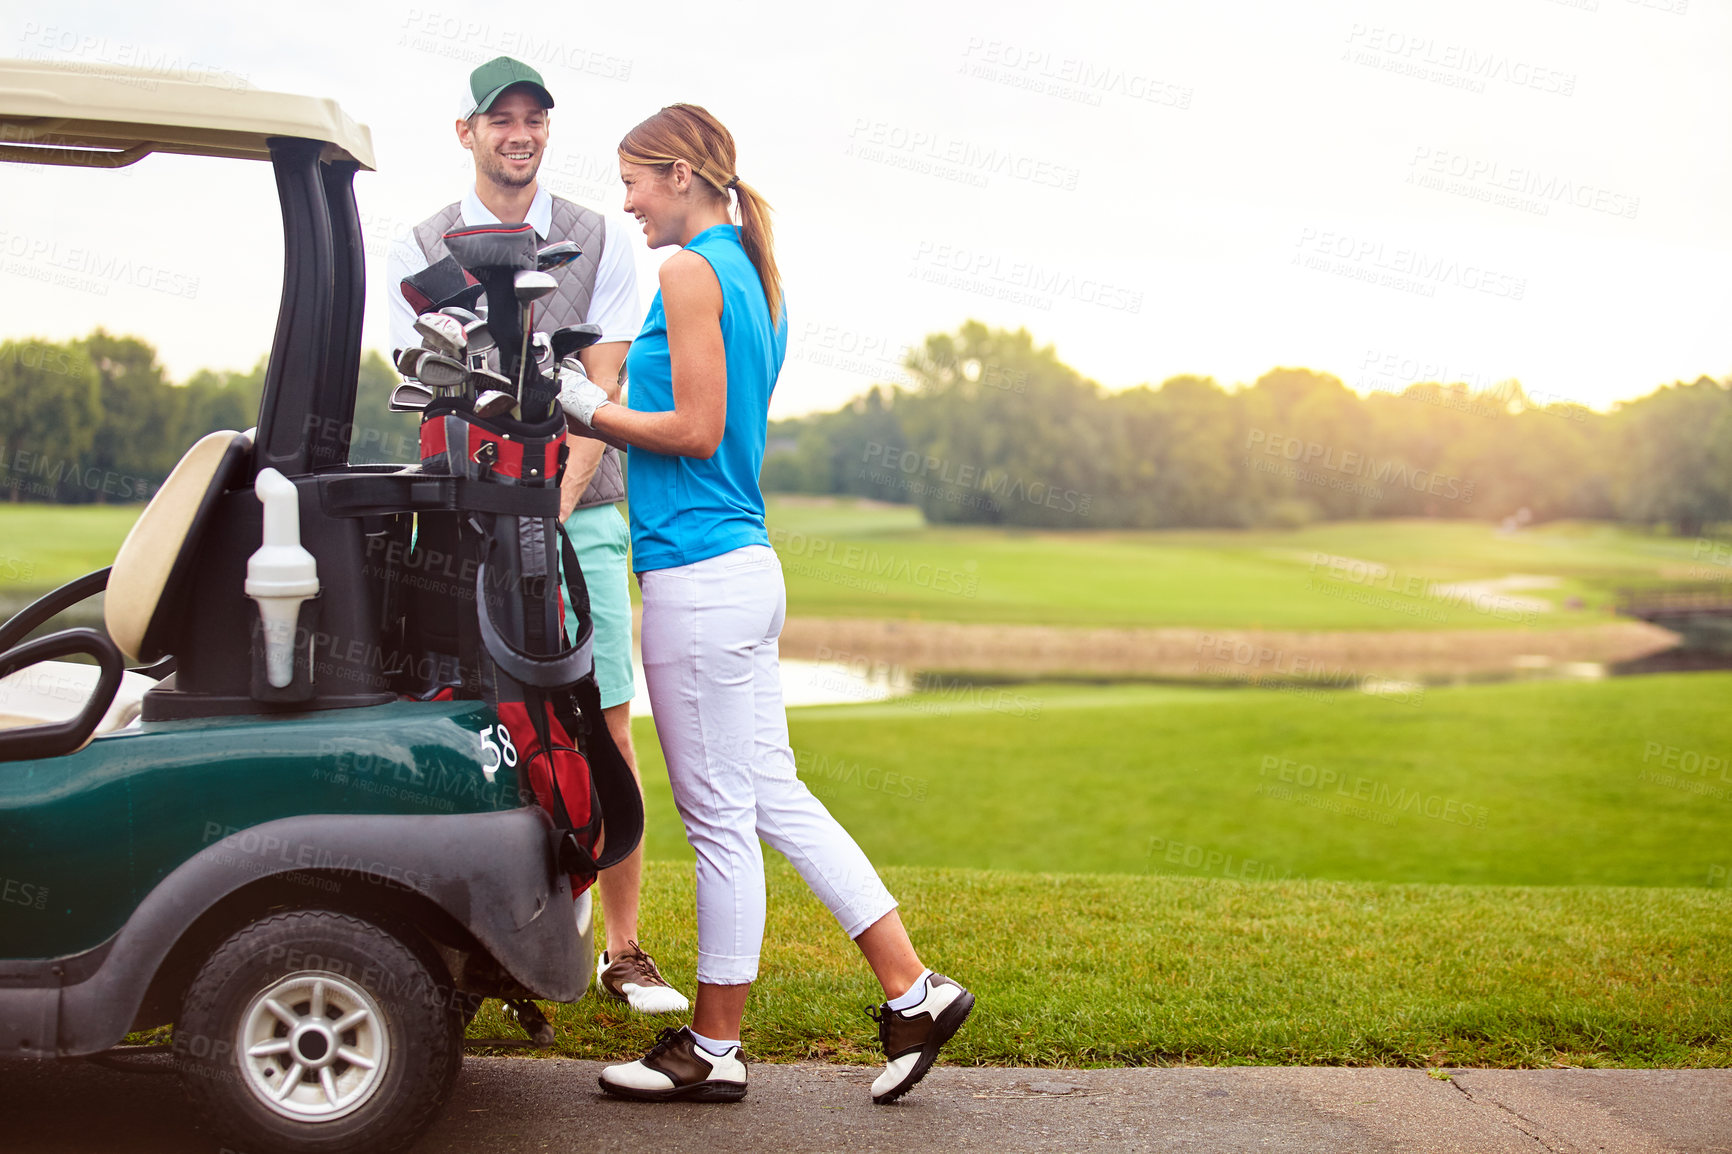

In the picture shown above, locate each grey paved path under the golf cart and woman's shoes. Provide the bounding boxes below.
[0,1057,1732,1154]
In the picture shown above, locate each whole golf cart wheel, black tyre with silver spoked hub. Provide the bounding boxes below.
[175,910,462,1154]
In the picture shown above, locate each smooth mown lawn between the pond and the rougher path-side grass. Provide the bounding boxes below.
[636,674,1732,887]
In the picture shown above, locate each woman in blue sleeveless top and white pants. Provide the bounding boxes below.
[561,104,973,1102]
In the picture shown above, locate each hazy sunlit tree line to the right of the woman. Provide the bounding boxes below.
[762,321,1732,535]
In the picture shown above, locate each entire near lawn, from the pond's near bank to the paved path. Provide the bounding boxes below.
[502,674,1732,1085]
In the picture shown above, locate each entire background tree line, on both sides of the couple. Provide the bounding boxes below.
[0,321,1732,535]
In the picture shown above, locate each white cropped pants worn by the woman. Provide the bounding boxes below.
[637,546,895,986]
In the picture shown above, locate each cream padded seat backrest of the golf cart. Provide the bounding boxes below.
[102,430,253,662]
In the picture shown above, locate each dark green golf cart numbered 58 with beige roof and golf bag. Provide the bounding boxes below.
[0,61,643,1152]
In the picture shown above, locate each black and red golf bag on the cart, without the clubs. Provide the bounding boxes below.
[409,402,643,892]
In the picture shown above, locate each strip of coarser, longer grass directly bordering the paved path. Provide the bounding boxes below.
[471,859,1732,1067]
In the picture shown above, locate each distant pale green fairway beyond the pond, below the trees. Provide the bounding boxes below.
[0,499,1711,629]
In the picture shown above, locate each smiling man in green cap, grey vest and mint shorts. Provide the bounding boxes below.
[386,55,688,1018]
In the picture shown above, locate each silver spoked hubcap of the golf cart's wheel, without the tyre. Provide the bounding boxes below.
[236,972,391,1121]
